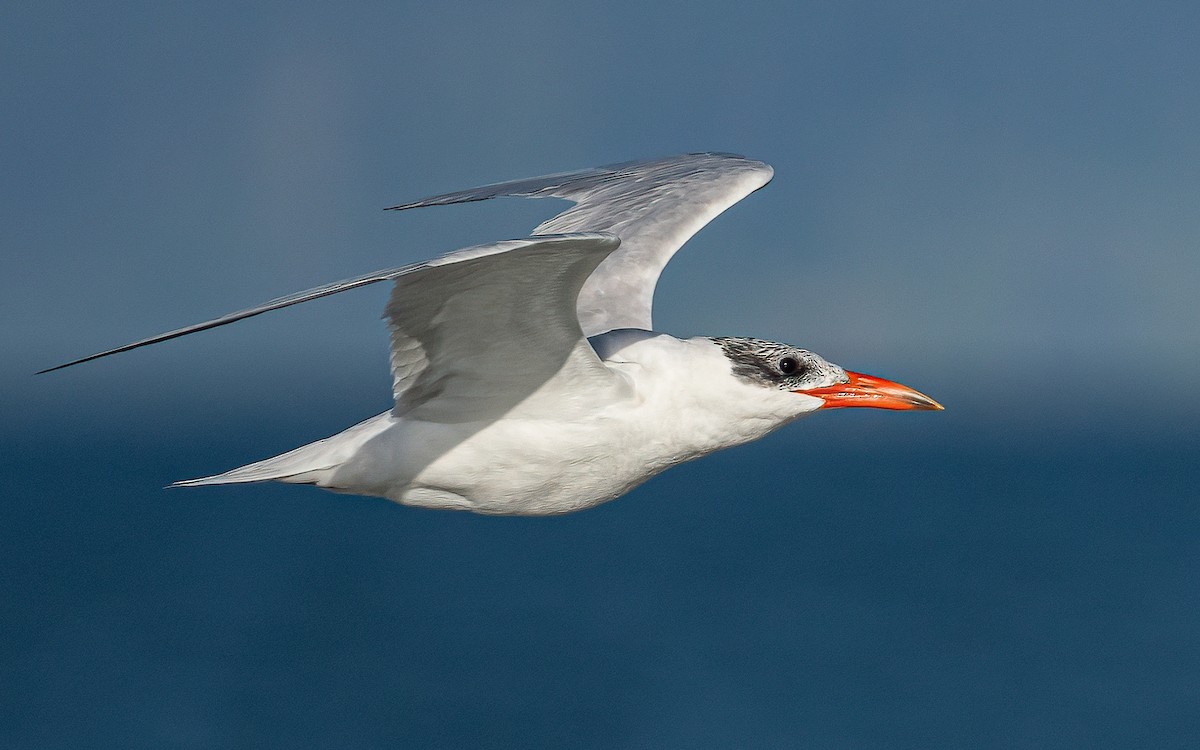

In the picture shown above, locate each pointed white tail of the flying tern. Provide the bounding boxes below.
[170,412,390,487]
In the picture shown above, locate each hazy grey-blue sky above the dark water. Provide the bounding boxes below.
[9,4,1200,427]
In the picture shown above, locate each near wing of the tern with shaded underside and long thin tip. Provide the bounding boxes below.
[42,234,620,421]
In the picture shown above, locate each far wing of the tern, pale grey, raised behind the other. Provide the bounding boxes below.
[389,154,774,336]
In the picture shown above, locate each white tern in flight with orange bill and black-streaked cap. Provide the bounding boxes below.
[43,154,942,515]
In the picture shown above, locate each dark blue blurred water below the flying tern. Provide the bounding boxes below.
[0,372,1200,748]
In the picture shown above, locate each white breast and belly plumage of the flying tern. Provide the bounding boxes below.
[317,337,811,515]
